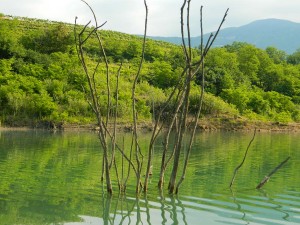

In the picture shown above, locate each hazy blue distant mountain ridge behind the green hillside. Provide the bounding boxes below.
[149,19,300,54]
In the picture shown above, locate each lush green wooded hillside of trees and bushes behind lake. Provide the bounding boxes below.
[0,14,300,126]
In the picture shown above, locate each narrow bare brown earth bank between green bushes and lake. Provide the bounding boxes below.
[0,117,300,132]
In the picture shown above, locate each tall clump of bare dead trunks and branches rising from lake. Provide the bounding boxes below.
[74,0,228,194]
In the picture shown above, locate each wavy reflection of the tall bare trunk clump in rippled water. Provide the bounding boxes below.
[94,192,188,225]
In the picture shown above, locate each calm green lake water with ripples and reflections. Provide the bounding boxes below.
[0,131,300,225]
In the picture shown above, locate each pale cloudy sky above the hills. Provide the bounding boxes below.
[0,0,300,37]
